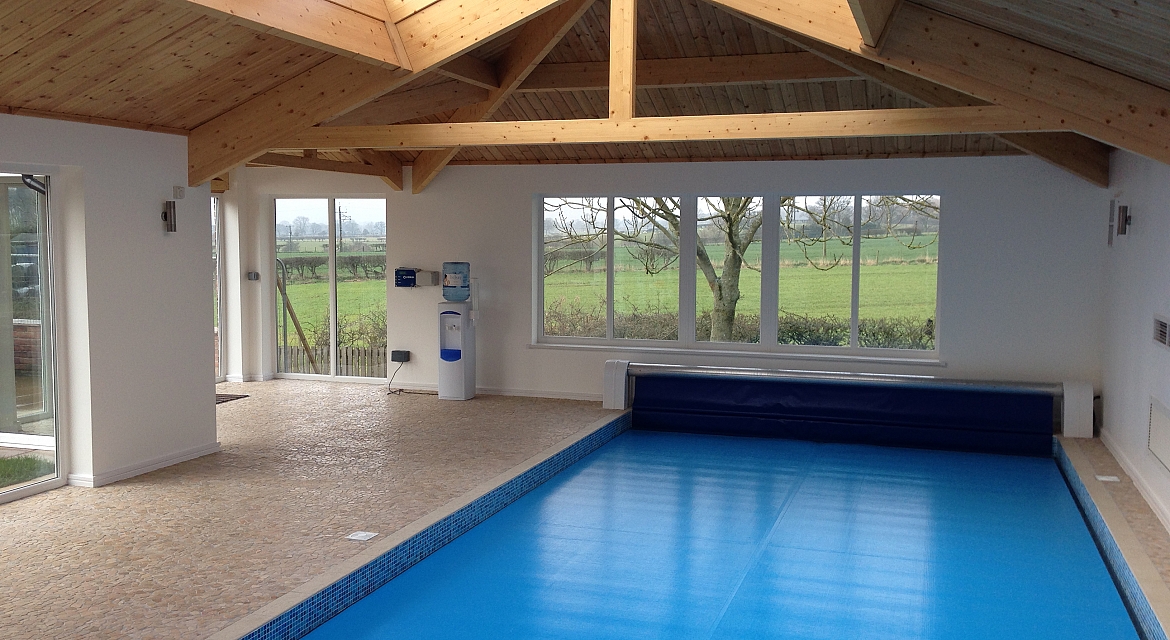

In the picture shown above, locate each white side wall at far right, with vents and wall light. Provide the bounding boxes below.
[1099,152,1170,527]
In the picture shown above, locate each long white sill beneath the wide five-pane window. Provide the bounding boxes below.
[528,342,947,366]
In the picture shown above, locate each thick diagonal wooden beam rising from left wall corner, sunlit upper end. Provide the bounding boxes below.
[187,0,566,186]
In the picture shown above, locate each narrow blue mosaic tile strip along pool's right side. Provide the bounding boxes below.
[1052,438,1166,640]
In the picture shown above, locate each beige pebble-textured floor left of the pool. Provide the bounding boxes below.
[0,380,617,640]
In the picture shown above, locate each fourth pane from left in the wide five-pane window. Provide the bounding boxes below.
[776,195,853,346]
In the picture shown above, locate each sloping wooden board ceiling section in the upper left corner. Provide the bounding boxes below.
[0,0,332,130]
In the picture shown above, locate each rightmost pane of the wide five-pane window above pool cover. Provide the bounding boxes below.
[858,195,941,350]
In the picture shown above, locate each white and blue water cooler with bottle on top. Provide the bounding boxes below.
[439,262,475,400]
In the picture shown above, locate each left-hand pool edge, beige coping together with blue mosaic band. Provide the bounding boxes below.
[208,411,631,640]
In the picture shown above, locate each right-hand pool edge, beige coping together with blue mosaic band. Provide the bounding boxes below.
[1053,436,1170,640]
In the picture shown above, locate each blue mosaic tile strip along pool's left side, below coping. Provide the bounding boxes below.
[243,412,631,640]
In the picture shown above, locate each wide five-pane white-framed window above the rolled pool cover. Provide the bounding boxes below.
[537,194,941,352]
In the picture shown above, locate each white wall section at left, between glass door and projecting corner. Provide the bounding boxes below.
[0,115,218,484]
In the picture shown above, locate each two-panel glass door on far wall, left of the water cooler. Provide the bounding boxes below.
[276,198,386,378]
